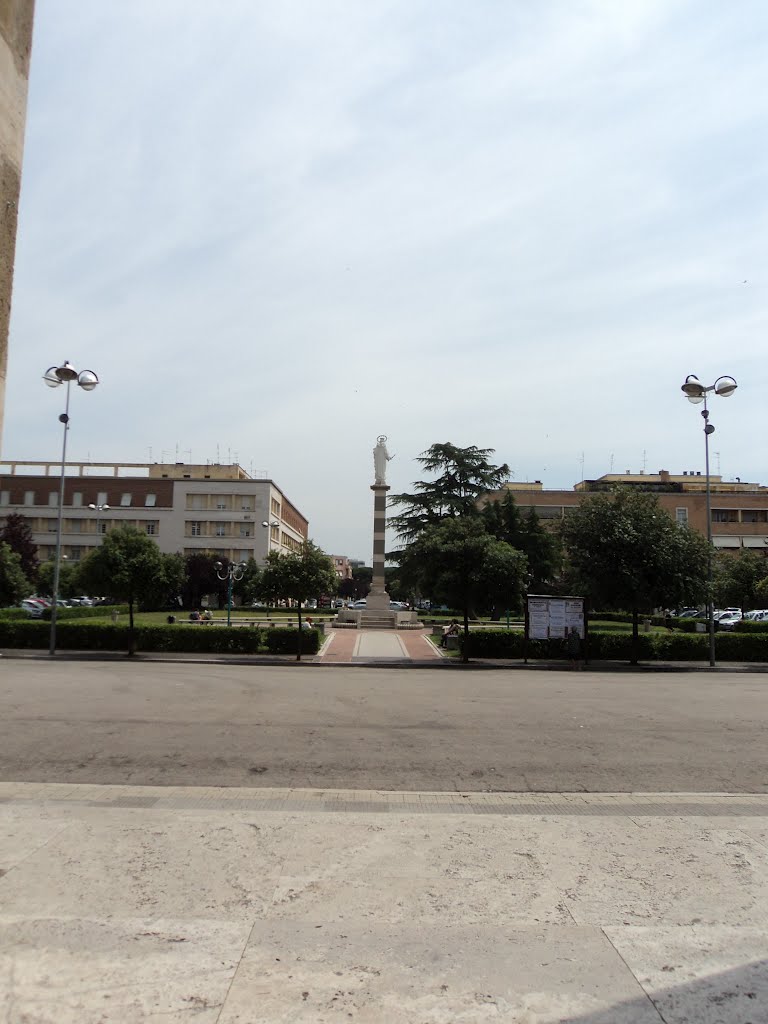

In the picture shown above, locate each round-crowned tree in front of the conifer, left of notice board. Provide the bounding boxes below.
[400,517,527,662]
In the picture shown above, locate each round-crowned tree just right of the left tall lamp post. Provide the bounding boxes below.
[80,526,169,654]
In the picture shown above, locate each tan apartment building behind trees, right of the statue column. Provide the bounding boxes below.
[492,469,768,554]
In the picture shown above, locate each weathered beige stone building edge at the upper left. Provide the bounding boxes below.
[0,0,35,451]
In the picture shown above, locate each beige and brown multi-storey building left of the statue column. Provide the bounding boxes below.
[0,462,309,563]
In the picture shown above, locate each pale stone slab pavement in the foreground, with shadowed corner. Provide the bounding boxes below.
[0,782,768,1024]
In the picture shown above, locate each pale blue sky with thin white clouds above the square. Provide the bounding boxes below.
[2,0,768,563]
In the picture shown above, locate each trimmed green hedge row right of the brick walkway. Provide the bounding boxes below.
[460,630,768,662]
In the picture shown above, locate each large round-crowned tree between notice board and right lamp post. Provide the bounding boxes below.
[561,489,709,665]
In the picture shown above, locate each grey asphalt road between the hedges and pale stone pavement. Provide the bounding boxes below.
[0,658,768,793]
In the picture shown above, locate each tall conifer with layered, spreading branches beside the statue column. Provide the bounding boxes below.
[389,441,509,543]
